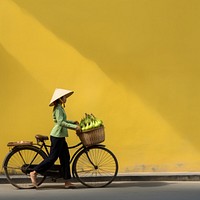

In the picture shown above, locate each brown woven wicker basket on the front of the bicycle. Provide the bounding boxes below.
[78,126,105,146]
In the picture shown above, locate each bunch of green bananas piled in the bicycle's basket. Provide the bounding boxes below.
[80,113,103,132]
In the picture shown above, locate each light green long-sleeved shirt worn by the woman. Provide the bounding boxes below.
[50,104,77,137]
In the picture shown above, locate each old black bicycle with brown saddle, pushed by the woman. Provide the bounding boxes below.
[3,135,118,189]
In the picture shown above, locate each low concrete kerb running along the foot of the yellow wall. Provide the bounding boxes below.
[0,172,200,184]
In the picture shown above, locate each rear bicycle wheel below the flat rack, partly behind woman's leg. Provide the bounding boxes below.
[3,146,47,189]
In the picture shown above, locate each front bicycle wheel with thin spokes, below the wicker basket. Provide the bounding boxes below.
[72,146,118,187]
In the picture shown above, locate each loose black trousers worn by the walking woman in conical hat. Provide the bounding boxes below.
[34,136,71,180]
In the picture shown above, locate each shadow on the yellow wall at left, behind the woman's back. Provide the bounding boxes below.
[0,45,51,141]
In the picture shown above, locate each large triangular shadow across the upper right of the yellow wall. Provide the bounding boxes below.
[13,0,200,147]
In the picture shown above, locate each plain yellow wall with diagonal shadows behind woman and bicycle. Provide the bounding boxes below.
[0,0,200,172]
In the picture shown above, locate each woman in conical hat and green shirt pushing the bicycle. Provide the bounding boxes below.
[30,89,80,188]
